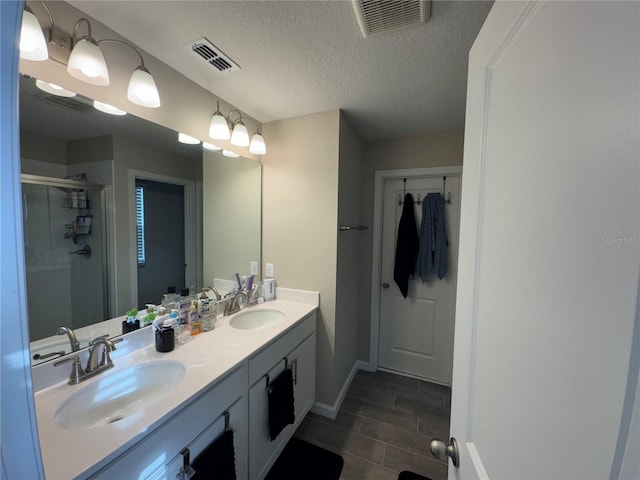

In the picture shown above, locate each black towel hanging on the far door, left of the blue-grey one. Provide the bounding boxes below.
[393,193,418,298]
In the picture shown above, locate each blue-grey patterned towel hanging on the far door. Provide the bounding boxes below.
[418,193,448,282]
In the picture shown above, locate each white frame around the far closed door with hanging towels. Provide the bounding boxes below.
[368,165,462,371]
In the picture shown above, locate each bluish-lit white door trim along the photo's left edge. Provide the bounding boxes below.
[0,2,45,479]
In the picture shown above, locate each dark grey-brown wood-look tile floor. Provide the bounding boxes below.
[296,370,451,480]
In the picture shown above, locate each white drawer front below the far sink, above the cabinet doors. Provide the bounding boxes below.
[249,312,316,385]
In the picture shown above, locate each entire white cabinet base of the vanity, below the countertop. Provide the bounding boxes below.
[85,312,316,480]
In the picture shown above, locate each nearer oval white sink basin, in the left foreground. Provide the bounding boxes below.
[53,360,185,430]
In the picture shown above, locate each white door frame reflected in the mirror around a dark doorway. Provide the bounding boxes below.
[128,169,202,303]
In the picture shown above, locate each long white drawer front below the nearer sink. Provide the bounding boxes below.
[91,366,246,480]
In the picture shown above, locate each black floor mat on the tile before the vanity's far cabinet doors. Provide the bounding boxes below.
[265,438,344,480]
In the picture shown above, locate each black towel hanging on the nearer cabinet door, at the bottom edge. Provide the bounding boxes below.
[191,428,236,480]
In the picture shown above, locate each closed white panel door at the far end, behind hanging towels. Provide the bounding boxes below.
[378,175,460,385]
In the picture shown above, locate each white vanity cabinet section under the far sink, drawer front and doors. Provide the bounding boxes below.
[249,313,316,480]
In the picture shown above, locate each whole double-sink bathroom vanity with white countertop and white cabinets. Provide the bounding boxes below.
[34,289,318,480]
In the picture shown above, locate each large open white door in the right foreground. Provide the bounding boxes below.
[449,2,640,479]
